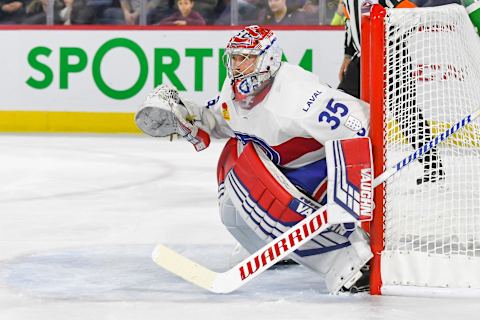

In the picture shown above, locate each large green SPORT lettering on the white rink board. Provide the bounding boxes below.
[26,38,313,100]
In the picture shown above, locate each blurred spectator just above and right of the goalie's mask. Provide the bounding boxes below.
[262,0,305,25]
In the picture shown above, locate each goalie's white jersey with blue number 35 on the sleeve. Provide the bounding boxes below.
[207,62,370,168]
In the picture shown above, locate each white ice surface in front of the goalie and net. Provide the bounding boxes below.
[0,135,480,320]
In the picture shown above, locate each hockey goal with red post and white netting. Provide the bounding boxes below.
[362,5,480,294]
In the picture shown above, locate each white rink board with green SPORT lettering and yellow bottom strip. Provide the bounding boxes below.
[0,29,343,132]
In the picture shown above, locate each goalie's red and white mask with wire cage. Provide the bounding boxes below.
[223,25,282,101]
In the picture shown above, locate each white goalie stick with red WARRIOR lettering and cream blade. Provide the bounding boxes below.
[152,110,480,293]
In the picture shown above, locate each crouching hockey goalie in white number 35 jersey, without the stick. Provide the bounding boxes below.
[135,25,372,293]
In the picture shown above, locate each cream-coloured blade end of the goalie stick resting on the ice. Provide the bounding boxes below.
[152,244,219,293]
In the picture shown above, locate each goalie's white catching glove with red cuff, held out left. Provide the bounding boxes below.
[135,84,215,151]
